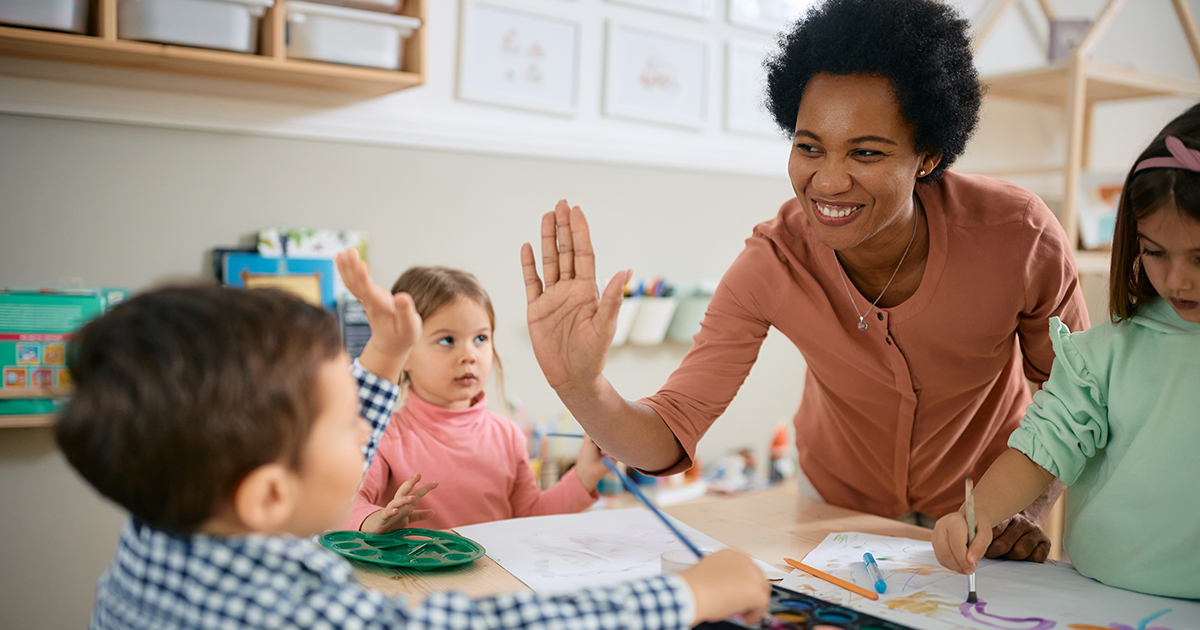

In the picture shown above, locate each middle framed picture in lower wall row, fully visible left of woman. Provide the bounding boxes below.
[604,22,708,127]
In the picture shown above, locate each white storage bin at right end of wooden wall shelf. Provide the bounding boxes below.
[287,1,421,70]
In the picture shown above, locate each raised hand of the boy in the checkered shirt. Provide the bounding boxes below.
[335,247,421,383]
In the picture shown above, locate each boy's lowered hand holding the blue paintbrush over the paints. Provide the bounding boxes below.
[679,550,770,625]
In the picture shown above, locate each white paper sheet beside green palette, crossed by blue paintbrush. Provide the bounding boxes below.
[455,508,784,593]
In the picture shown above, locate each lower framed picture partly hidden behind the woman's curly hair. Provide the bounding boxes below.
[725,40,780,138]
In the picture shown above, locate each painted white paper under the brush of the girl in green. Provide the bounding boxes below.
[781,532,1200,630]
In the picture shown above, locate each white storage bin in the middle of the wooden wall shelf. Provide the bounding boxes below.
[116,0,275,53]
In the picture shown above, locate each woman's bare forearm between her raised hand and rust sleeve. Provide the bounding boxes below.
[557,376,684,472]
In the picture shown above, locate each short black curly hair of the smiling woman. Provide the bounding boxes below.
[763,0,983,181]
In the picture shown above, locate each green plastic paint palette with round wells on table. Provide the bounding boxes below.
[319,528,487,569]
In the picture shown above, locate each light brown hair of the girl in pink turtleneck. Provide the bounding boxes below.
[391,266,508,415]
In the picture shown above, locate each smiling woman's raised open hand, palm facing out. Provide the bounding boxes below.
[521,199,631,390]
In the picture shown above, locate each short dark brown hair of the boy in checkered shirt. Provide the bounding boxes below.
[54,287,349,533]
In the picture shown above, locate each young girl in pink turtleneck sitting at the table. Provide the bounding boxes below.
[342,266,606,534]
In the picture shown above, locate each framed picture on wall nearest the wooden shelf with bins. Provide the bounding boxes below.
[458,0,580,115]
